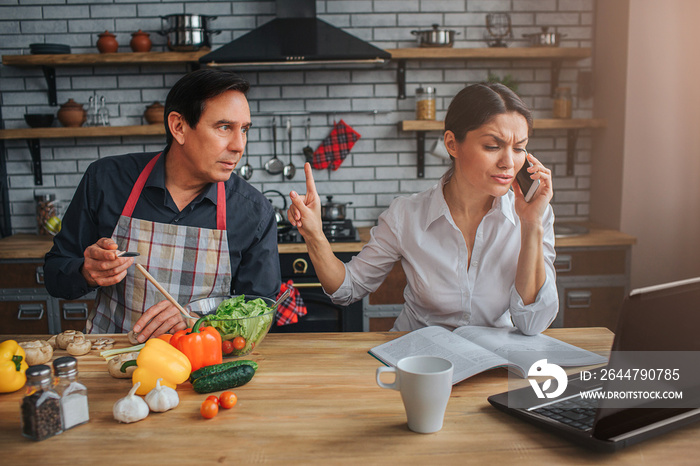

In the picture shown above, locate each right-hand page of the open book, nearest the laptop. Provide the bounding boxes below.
[454,326,607,377]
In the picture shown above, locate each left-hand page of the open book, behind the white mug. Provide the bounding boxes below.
[370,327,508,384]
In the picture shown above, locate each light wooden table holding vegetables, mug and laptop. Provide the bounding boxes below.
[0,328,700,465]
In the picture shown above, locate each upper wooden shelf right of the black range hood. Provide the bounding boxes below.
[387,47,591,60]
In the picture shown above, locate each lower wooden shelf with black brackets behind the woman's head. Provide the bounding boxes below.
[399,118,606,178]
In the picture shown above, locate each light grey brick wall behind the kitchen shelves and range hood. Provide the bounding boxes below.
[0,0,594,233]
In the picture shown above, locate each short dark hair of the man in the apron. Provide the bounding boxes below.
[164,68,250,147]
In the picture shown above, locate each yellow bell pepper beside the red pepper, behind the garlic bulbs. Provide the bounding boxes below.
[131,338,192,395]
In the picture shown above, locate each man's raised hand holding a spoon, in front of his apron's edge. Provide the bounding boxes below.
[80,238,134,287]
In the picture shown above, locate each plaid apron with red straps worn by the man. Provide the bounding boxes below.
[87,154,231,333]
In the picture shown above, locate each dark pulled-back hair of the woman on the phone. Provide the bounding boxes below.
[445,83,532,142]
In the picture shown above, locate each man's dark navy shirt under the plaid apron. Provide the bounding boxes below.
[44,152,281,299]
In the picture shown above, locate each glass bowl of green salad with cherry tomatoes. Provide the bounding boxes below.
[184,295,277,357]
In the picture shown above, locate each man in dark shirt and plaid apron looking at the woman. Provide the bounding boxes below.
[44,69,280,341]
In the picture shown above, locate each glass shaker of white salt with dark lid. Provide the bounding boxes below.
[53,356,90,430]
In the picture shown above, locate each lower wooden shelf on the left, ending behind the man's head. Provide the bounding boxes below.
[0,123,165,139]
